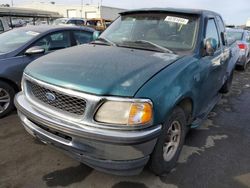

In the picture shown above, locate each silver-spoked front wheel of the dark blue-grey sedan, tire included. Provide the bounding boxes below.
[0,81,15,118]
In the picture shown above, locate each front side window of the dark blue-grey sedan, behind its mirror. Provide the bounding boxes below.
[33,31,71,52]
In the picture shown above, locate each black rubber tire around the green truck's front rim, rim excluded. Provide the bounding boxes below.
[149,107,187,176]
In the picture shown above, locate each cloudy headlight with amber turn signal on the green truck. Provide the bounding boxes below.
[95,101,153,125]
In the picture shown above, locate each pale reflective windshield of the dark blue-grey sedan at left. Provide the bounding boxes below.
[0,29,40,53]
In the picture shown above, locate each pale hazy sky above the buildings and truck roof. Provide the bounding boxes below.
[0,0,250,25]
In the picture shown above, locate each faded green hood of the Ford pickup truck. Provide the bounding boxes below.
[25,44,180,97]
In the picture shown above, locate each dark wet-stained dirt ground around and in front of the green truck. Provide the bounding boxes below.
[0,68,250,188]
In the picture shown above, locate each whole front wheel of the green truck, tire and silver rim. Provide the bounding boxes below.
[150,107,187,175]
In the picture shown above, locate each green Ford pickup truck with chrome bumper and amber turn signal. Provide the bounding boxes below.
[15,8,235,175]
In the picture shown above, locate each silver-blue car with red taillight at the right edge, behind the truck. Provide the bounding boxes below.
[227,28,250,70]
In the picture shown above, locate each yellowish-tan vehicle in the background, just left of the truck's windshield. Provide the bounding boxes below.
[86,18,112,31]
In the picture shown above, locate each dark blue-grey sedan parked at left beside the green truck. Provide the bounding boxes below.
[0,26,94,118]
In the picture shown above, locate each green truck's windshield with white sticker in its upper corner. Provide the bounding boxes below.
[100,13,198,52]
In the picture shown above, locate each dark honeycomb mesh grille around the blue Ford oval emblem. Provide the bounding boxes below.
[26,80,86,115]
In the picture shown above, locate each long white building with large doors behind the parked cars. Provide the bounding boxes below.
[19,2,124,20]
